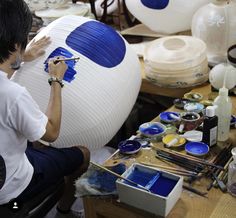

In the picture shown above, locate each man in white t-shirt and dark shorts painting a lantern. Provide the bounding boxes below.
[0,0,90,213]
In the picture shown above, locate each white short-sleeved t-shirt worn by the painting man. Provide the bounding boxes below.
[0,71,48,205]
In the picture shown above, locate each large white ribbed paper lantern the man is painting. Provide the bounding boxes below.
[13,15,141,149]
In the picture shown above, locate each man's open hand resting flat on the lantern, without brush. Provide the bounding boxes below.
[23,36,51,61]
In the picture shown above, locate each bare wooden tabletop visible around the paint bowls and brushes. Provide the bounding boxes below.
[84,85,236,218]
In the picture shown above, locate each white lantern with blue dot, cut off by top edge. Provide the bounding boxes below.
[125,0,210,34]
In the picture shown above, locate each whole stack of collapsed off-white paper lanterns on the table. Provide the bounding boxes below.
[144,36,209,88]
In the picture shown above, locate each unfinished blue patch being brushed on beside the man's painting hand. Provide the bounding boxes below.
[44,47,77,82]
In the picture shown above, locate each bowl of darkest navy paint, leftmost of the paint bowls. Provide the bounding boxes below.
[118,140,142,154]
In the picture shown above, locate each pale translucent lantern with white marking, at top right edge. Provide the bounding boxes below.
[192,1,236,65]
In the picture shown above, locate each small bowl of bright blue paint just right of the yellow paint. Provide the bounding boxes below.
[185,142,209,156]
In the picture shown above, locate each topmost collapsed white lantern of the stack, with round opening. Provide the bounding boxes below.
[144,35,206,70]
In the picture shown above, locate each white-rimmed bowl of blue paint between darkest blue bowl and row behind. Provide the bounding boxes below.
[139,122,166,138]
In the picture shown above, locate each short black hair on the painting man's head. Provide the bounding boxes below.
[0,0,32,63]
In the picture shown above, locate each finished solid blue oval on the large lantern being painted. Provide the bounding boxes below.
[66,21,126,68]
